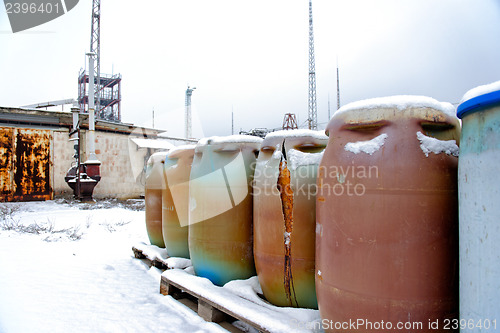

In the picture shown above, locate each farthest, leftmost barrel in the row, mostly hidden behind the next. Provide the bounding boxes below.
[144,152,167,247]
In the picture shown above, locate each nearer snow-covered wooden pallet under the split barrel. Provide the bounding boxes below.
[160,269,318,333]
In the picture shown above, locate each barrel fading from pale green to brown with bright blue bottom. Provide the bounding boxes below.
[189,135,262,285]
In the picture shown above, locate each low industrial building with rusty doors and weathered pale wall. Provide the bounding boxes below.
[0,107,194,201]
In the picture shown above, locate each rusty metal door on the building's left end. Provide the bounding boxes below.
[0,127,52,201]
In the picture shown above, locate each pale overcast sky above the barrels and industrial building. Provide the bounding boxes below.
[0,0,500,137]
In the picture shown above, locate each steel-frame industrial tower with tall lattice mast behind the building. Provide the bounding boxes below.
[78,0,121,122]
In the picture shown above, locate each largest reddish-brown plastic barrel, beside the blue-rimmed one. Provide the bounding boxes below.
[316,96,460,332]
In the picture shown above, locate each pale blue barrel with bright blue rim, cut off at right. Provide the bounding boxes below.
[457,81,500,326]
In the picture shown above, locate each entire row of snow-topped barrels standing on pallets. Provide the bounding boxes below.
[145,87,500,332]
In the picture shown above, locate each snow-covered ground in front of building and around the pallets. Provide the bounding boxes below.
[0,200,322,333]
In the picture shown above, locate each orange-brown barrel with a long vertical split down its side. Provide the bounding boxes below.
[253,130,328,308]
